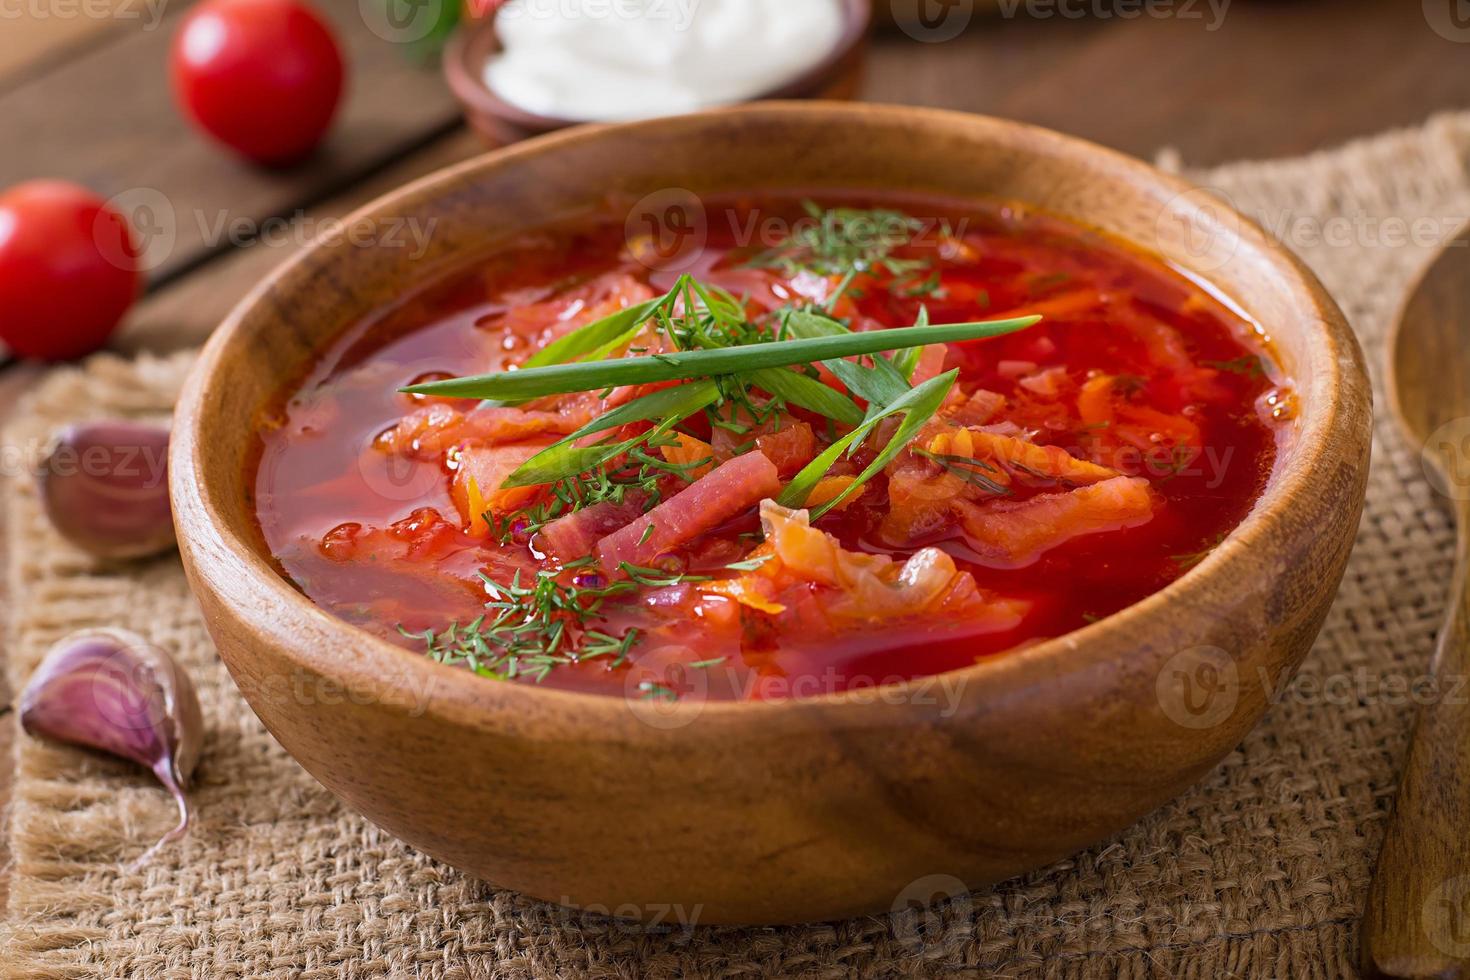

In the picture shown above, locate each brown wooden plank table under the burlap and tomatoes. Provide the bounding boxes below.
[0,0,1470,910]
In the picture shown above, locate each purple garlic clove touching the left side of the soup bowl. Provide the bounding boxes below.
[37,420,173,558]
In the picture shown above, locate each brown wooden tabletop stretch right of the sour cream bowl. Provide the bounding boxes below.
[866,0,1470,166]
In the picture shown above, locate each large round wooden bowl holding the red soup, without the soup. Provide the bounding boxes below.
[171,103,1370,924]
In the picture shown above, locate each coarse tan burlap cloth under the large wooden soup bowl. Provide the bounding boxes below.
[0,115,1470,980]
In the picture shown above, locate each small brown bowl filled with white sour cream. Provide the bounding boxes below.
[444,0,872,145]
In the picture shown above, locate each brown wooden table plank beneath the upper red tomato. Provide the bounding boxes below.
[0,0,459,281]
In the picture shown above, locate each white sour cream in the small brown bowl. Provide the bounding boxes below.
[485,0,844,122]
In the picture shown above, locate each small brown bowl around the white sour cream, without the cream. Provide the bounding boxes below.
[442,0,873,148]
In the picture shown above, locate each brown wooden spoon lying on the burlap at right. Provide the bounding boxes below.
[1361,228,1470,977]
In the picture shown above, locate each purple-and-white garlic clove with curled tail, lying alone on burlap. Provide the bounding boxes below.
[21,629,204,864]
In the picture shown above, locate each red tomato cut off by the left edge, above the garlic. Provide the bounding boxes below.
[0,181,140,360]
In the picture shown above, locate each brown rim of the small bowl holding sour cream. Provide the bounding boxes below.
[441,0,873,132]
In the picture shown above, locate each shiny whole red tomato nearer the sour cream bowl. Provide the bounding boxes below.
[169,0,343,165]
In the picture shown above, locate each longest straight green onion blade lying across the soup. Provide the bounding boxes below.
[401,316,1041,401]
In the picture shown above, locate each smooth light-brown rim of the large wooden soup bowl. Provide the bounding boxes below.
[169,101,1372,728]
